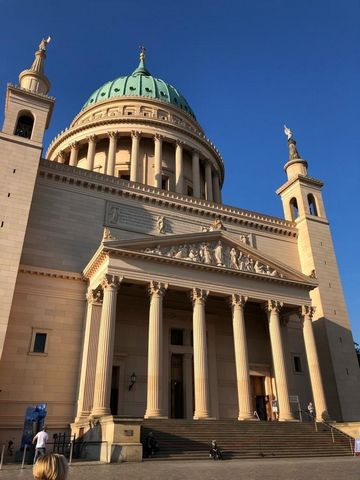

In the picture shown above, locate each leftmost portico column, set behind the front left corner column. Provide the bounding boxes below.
[76,288,102,421]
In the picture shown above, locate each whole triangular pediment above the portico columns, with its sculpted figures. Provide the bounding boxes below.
[103,231,317,288]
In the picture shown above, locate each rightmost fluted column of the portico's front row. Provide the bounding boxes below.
[301,305,327,422]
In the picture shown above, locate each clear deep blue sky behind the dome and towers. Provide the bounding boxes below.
[0,0,360,342]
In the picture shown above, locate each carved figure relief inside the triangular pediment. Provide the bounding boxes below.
[143,240,282,277]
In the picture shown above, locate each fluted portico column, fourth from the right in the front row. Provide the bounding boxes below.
[191,288,210,420]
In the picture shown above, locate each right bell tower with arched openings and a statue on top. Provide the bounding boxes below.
[276,127,360,421]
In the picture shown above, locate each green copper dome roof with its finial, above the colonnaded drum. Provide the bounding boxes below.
[82,52,196,118]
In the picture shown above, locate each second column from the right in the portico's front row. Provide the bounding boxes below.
[267,300,293,420]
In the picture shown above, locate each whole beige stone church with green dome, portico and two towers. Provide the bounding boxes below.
[0,40,360,458]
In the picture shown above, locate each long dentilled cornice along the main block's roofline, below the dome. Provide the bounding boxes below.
[38,159,297,238]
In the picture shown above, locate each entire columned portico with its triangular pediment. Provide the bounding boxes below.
[77,231,326,428]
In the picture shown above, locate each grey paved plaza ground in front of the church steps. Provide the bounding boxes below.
[0,457,360,480]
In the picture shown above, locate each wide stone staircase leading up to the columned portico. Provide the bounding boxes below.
[141,420,353,460]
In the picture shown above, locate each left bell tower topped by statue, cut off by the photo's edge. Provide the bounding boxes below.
[0,37,54,356]
